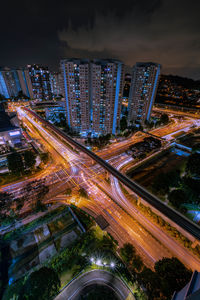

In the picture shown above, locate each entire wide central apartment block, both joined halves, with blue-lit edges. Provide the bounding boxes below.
[61,59,124,136]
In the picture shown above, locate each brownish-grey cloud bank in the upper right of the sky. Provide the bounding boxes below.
[58,0,200,78]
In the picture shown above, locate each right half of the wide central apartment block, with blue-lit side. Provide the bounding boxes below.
[90,60,124,136]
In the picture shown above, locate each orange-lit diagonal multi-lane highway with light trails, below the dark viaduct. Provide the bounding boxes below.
[10,106,200,270]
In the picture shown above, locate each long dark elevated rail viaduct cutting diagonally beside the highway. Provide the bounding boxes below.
[23,108,200,241]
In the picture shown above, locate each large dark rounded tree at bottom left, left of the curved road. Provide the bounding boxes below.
[19,267,61,300]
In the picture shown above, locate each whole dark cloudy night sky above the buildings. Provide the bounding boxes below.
[0,0,200,79]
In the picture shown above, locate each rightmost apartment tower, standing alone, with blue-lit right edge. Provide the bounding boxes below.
[128,62,160,125]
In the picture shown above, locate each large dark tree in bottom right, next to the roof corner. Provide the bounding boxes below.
[155,257,192,297]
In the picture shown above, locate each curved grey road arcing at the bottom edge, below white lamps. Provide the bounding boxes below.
[55,270,135,300]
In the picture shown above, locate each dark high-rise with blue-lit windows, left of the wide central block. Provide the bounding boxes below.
[27,64,52,100]
